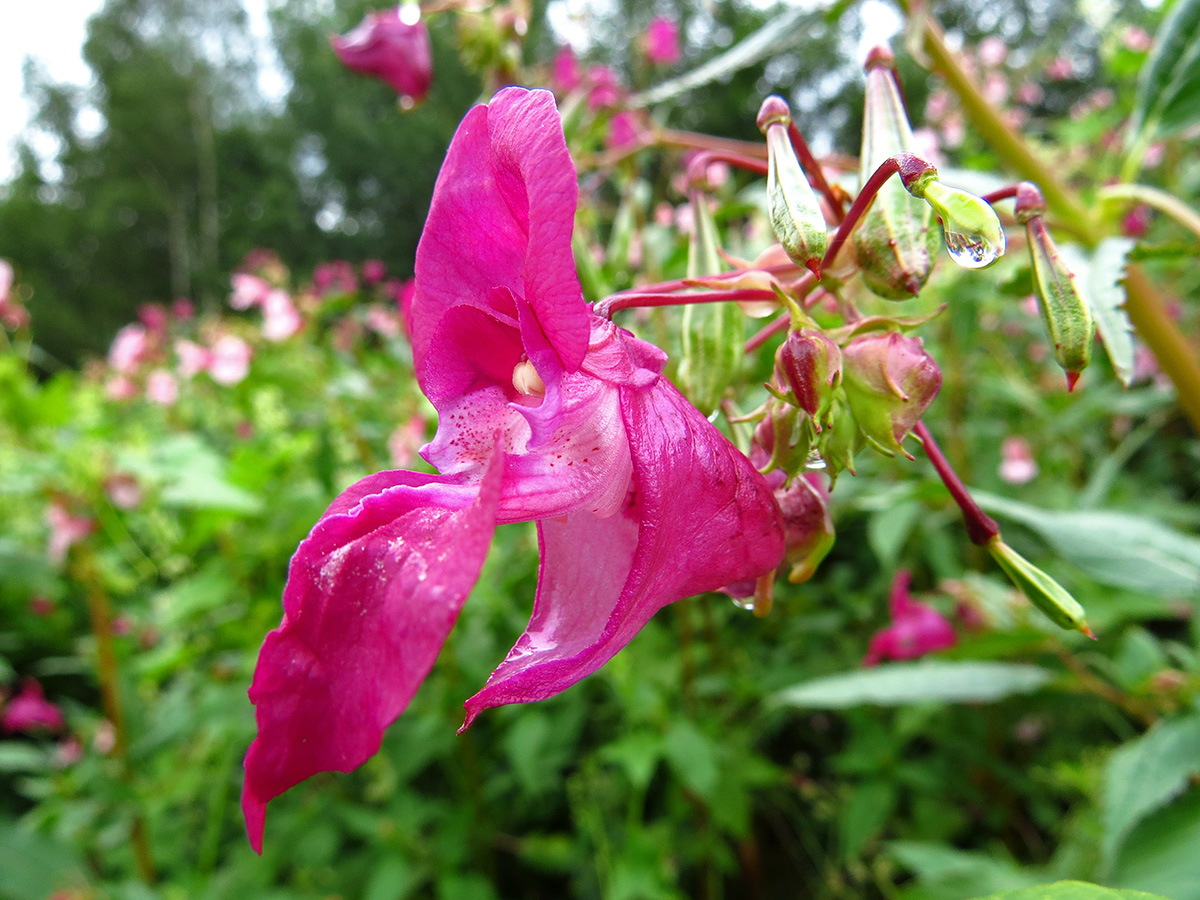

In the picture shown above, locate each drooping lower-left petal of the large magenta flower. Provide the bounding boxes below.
[242,454,503,852]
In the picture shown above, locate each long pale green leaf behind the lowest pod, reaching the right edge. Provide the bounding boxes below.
[974,491,1200,594]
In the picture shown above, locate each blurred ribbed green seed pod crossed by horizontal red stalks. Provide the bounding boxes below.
[679,191,745,415]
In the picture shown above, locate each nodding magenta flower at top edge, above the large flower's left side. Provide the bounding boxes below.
[329,4,433,107]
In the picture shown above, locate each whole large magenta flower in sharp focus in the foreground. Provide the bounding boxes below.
[242,88,784,848]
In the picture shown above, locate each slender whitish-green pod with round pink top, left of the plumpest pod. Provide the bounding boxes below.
[757,95,829,277]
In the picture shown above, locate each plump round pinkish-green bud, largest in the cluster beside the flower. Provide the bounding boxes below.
[842,331,942,458]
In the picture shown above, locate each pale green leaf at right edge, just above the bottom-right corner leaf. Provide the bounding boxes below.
[1100,715,1200,869]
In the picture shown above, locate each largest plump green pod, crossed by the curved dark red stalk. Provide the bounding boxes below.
[853,47,938,300]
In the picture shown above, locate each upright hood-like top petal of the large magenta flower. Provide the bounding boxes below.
[413,88,589,379]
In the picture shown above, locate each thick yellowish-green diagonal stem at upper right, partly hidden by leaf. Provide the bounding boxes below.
[900,9,1200,433]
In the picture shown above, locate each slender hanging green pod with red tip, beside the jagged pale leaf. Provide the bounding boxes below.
[1016,181,1096,389]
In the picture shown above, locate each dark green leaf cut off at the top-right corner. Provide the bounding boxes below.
[1129,0,1200,144]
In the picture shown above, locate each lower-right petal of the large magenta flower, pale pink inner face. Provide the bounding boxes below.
[464,367,784,727]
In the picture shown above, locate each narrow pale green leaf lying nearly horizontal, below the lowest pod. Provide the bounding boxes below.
[775,660,1051,709]
